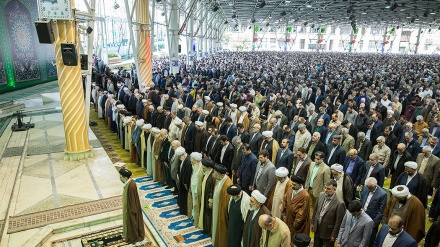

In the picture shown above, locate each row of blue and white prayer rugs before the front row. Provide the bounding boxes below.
[135,176,212,247]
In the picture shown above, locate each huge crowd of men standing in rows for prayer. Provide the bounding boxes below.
[92,52,440,247]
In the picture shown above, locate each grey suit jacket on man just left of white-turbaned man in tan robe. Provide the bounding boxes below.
[253,160,276,198]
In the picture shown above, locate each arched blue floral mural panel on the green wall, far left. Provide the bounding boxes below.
[5,0,40,82]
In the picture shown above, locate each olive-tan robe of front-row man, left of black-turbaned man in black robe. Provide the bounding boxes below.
[212,175,232,247]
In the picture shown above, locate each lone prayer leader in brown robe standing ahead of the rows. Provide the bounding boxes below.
[119,168,145,244]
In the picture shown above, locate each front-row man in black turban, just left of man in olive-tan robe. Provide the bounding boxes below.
[198,159,217,234]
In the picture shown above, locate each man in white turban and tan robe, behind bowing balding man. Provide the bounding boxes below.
[266,167,292,218]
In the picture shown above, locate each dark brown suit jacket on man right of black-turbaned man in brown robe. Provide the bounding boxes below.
[312,192,345,240]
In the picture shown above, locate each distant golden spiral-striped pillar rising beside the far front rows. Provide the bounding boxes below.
[136,0,153,87]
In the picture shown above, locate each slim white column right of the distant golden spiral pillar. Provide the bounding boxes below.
[168,0,180,75]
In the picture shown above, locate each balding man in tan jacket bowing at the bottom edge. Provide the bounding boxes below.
[258,214,291,247]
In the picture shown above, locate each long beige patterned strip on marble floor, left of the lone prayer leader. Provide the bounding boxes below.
[8,196,122,234]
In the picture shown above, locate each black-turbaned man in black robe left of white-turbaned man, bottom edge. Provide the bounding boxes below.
[227,184,250,247]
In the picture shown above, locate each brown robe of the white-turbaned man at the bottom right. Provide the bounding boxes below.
[382,195,426,243]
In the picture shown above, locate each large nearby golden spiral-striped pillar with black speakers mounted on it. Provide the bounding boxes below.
[53,18,93,161]
